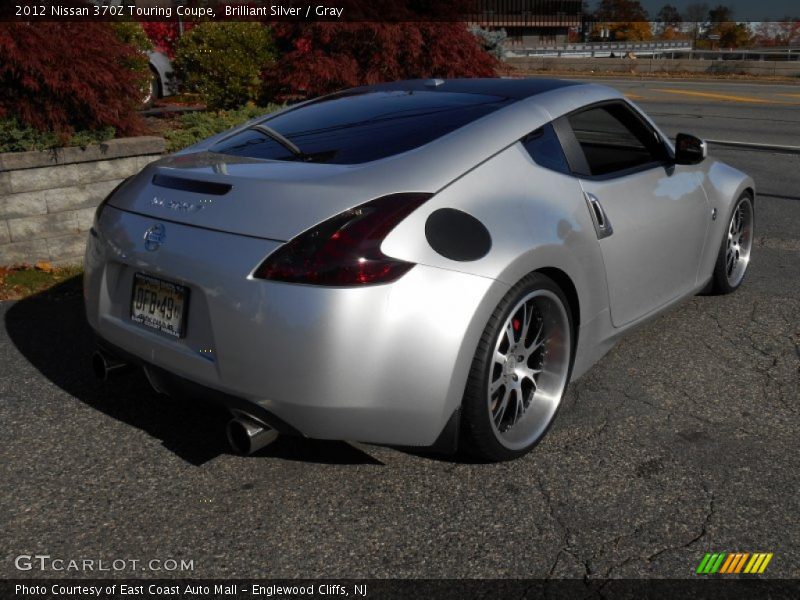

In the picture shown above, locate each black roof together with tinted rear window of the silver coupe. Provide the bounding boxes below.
[213,78,588,165]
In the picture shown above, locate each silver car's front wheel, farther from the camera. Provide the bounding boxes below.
[711,194,755,294]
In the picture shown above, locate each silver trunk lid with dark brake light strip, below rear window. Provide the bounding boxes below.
[109,152,400,241]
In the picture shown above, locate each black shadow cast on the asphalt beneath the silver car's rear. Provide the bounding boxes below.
[5,277,383,466]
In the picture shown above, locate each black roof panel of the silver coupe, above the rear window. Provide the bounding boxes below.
[345,77,581,100]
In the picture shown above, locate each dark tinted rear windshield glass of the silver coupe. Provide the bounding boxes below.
[210,91,513,164]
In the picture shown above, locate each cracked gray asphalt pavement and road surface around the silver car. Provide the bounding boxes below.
[0,84,800,578]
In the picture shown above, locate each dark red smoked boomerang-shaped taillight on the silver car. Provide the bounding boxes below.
[253,193,432,286]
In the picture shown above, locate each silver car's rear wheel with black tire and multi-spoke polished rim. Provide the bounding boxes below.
[463,274,573,461]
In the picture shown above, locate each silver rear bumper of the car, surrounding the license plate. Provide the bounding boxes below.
[84,207,507,446]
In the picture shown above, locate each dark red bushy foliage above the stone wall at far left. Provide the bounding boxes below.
[0,22,142,136]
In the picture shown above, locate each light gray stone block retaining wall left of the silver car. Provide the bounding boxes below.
[0,137,165,265]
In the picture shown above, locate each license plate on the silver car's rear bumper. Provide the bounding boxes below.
[131,273,189,338]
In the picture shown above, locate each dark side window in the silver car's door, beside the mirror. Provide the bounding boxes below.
[568,104,667,176]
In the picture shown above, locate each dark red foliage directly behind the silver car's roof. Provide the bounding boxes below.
[265,22,498,101]
